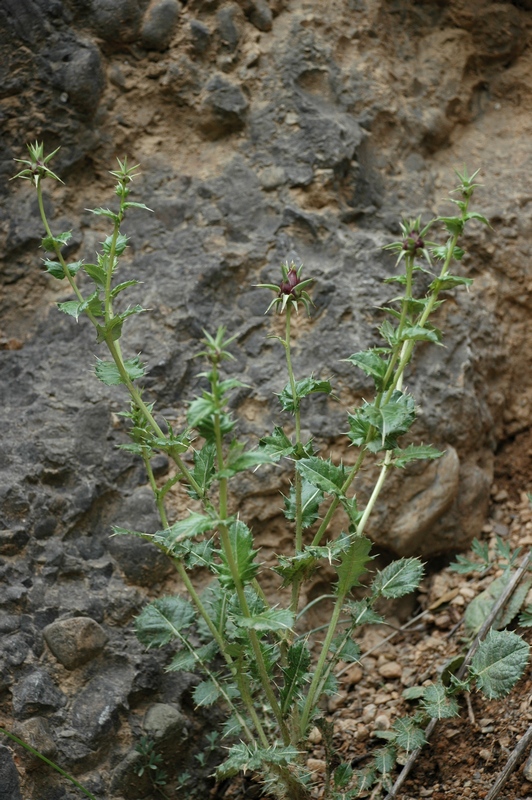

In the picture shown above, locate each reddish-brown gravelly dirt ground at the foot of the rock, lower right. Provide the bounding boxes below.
[212,434,532,800]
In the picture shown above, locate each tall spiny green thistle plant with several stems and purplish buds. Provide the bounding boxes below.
[17,144,526,800]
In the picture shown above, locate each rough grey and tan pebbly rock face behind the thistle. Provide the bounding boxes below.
[0,0,532,800]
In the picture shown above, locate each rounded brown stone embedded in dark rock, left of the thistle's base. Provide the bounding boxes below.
[43,617,109,669]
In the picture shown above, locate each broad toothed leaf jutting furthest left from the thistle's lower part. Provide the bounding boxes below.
[135,596,196,647]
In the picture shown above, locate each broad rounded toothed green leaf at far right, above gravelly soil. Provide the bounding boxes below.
[470,629,530,700]
